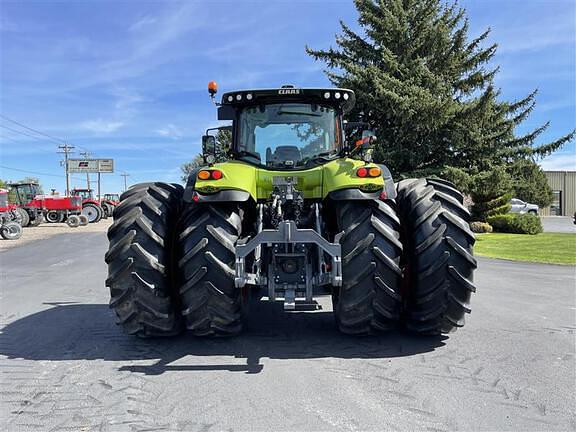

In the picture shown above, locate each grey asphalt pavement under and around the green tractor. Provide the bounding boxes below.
[0,233,576,432]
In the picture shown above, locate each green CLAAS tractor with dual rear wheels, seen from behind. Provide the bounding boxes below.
[105,83,476,337]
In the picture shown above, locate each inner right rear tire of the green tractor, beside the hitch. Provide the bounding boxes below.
[332,201,402,334]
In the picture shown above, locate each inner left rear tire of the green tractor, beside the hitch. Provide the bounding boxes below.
[178,203,243,336]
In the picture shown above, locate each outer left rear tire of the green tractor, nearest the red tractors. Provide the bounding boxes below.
[105,183,182,337]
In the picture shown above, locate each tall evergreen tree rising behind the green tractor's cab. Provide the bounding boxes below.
[306,0,575,176]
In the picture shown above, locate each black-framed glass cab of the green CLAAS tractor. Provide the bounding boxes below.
[203,85,373,171]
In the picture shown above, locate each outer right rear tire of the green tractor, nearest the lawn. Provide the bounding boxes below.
[396,179,477,335]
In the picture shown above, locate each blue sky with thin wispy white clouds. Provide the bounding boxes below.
[0,0,576,192]
